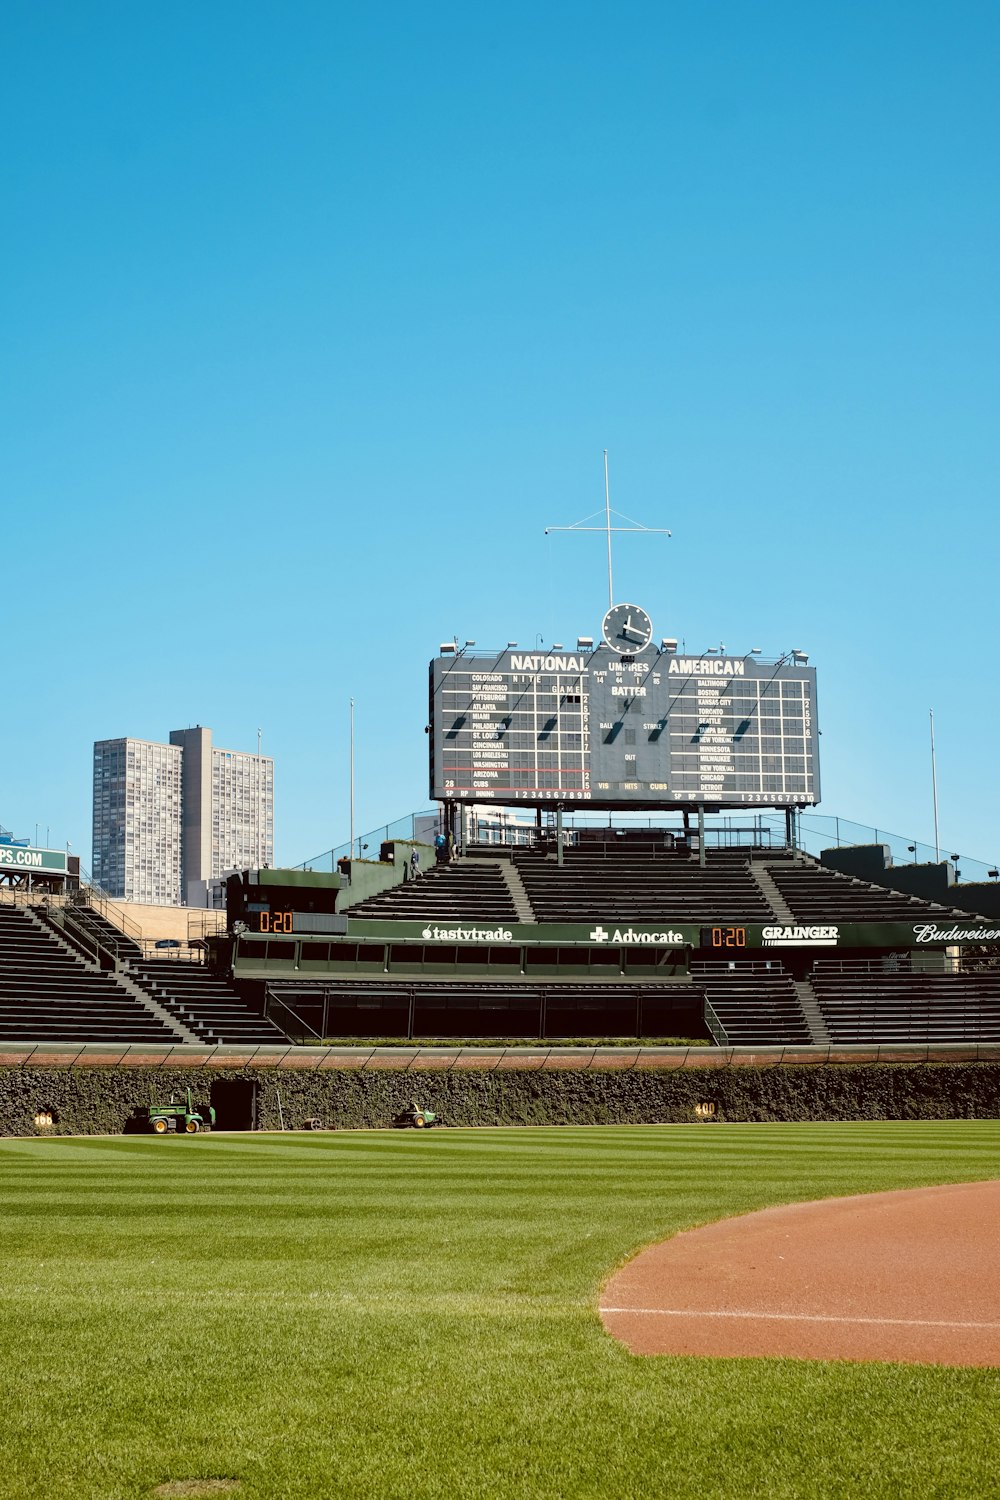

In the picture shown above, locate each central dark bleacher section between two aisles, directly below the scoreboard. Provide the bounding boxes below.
[514,842,774,923]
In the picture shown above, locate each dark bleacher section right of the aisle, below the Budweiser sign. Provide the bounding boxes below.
[810,962,1000,1046]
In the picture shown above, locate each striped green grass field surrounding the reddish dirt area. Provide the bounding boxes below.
[0,1121,1000,1500]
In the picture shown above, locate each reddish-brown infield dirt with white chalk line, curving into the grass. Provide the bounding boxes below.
[601,1182,1000,1367]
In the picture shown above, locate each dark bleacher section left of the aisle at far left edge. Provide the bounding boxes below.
[0,906,178,1043]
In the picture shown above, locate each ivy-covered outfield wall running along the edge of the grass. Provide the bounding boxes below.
[0,1062,1000,1136]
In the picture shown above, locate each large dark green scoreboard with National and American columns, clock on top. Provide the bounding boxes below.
[429,627,820,809]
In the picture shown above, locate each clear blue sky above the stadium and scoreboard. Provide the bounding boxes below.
[0,0,1000,863]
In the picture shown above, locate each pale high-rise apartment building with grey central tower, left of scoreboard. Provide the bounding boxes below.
[93,726,274,906]
